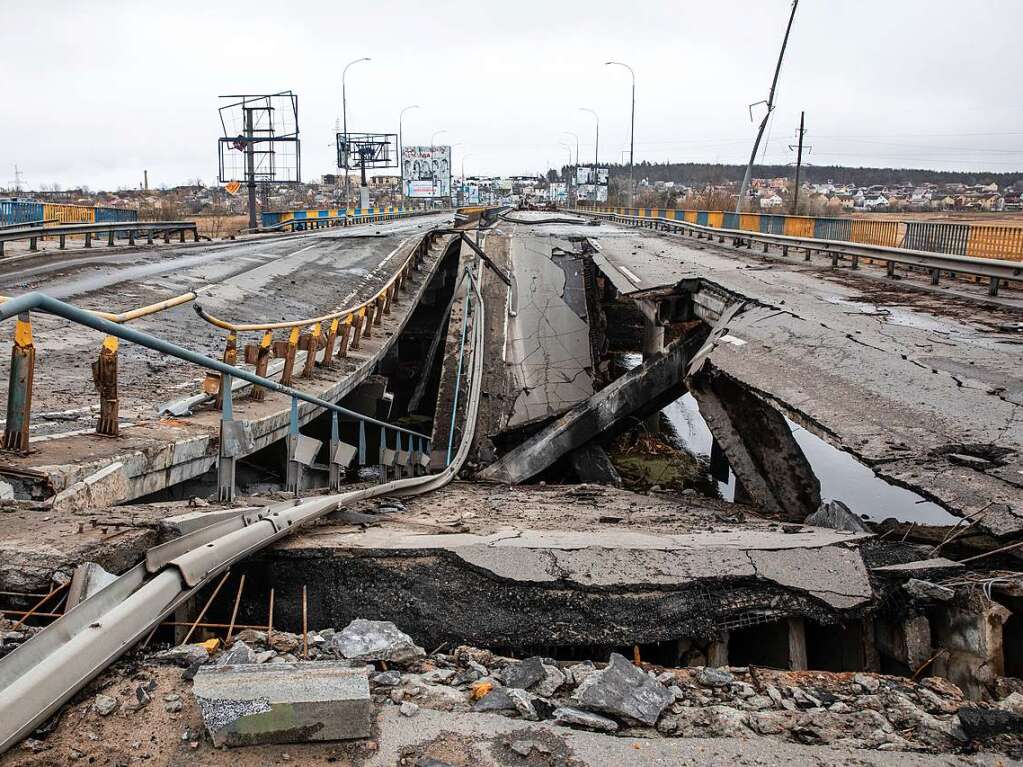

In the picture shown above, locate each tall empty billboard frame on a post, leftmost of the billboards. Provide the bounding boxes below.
[217,91,302,229]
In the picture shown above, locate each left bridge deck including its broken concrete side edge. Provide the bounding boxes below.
[0,218,456,503]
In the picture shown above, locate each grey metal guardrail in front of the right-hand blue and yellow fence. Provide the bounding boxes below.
[572,210,1023,296]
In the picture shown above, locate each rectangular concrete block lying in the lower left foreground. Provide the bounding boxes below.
[192,662,372,748]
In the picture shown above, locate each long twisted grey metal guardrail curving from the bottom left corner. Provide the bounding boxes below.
[0,267,486,754]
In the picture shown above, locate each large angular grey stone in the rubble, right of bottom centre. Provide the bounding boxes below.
[573,652,674,726]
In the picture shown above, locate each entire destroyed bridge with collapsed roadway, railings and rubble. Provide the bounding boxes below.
[0,208,1023,765]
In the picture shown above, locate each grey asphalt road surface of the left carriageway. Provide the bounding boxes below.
[0,214,450,436]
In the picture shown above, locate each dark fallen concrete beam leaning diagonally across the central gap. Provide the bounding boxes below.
[479,340,687,482]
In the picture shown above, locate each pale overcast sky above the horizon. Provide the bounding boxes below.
[0,0,1023,188]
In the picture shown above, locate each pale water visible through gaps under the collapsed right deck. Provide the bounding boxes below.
[622,354,961,525]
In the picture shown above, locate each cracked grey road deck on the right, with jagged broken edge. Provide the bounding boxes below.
[560,216,1023,535]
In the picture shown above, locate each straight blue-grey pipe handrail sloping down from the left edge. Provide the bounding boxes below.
[0,291,429,439]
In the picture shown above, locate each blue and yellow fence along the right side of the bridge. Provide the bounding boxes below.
[596,208,1023,261]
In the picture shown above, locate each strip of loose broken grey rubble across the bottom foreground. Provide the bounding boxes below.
[152,620,1023,755]
